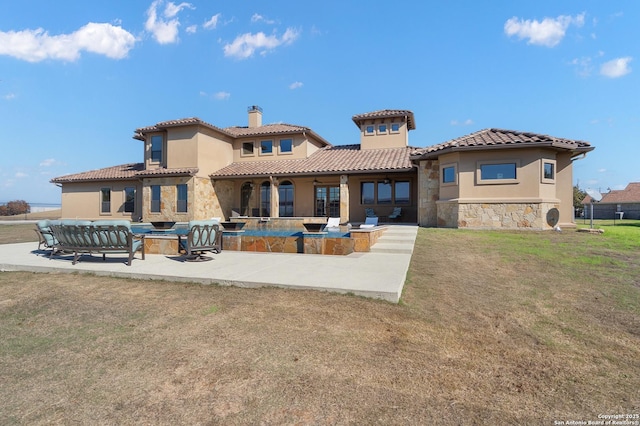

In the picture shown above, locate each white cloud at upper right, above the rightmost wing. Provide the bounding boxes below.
[504,13,585,47]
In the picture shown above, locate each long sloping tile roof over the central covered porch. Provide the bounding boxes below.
[211,145,415,178]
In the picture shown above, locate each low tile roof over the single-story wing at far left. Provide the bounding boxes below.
[51,163,198,183]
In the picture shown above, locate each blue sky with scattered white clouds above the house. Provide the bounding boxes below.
[0,0,640,203]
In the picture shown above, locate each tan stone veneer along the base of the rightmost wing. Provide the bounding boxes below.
[438,202,559,230]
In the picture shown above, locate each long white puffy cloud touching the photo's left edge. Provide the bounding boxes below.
[0,22,136,62]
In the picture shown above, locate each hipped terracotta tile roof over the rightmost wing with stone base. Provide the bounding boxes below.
[411,129,594,160]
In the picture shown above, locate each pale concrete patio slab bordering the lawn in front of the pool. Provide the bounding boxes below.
[0,225,417,303]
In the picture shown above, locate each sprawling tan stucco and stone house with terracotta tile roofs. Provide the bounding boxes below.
[52,106,593,229]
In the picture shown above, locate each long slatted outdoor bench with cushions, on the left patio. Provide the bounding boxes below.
[49,220,144,266]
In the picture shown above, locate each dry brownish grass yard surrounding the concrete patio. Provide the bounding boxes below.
[0,220,640,425]
